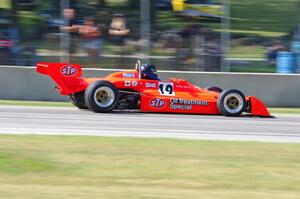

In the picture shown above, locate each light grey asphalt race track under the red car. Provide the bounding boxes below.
[0,106,300,143]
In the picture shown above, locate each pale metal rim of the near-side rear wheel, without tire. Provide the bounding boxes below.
[94,86,115,108]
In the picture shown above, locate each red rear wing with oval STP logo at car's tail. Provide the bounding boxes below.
[36,62,88,95]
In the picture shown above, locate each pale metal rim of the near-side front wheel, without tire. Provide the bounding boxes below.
[223,93,244,114]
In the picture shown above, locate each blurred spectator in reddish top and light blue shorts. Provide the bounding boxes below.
[79,17,101,64]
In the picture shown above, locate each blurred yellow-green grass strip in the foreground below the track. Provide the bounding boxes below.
[0,135,300,199]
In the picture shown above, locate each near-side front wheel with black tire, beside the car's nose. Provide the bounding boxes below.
[217,89,247,117]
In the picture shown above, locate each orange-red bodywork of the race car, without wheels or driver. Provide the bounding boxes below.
[37,63,270,117]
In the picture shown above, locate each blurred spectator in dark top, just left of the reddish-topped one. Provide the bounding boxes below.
[61,8,79,54]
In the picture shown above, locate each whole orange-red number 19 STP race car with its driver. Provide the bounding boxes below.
[37,61,270,117]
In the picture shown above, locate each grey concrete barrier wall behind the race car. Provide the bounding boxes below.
[0,66,300,107]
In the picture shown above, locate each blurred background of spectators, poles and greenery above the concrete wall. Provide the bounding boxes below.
[0,0,300,73]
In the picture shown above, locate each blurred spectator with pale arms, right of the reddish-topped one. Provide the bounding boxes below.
[108,14,130,44]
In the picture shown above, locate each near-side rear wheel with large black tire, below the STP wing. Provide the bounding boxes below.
[84,80,119,113]
